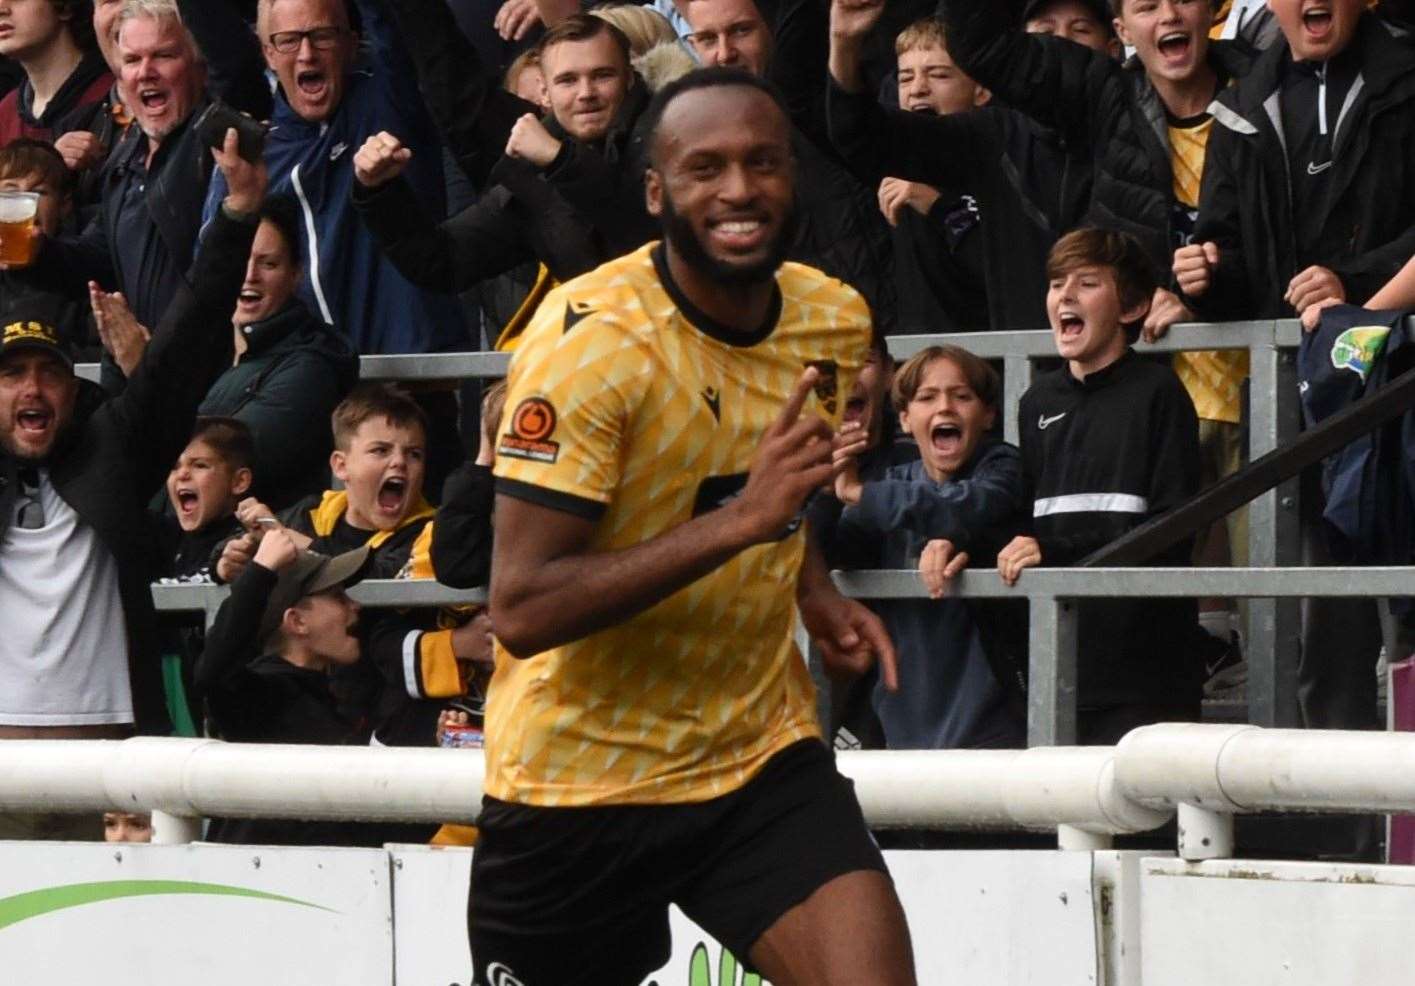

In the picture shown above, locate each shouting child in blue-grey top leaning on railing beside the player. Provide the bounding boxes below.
[835,347,1024,750]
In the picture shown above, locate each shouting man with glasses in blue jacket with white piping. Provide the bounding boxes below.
[207,0,468,354]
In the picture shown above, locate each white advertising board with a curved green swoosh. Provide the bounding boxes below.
[0,842,393,986]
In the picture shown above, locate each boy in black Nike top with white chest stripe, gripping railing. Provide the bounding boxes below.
[998,229,1204,746]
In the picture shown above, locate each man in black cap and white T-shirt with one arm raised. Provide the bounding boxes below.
[0,133,266,839]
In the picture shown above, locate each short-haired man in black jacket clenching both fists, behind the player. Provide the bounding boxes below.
[354,14,654,309]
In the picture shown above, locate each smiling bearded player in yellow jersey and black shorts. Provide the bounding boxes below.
[470,69,914,986]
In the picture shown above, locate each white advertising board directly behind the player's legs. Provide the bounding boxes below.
[392,846,1098,986]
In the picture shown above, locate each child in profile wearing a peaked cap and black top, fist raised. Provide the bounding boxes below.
[195,528,382,846]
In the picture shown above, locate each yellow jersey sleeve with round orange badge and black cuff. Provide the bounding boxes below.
[495,290,648,521]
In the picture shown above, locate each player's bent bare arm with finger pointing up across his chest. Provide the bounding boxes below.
[491,369,832,658]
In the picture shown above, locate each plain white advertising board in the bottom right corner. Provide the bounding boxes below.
[1140,860,1415,986]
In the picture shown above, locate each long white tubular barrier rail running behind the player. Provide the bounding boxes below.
[0,723,1415,859]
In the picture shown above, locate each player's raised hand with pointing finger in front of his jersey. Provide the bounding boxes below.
[729,366,833,543]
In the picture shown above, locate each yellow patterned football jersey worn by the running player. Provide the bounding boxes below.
[485,243,870,805]
